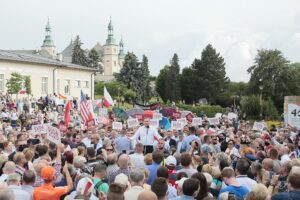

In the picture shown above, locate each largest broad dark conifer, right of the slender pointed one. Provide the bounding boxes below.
[191,44,229,105]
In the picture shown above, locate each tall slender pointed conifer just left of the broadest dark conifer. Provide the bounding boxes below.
[165,53,181,102]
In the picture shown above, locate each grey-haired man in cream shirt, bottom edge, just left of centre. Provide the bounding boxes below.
[124,169,145,200]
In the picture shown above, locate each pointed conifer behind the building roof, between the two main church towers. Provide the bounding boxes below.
[72,35,89,67]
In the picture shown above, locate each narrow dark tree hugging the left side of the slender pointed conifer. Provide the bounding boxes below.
[155,65,170,102]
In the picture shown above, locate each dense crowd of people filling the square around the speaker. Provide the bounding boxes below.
[0,96,300,200]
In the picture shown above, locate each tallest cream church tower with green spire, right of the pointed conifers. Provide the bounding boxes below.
[102,18,120,76]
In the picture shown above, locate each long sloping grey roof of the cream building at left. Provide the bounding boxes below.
[0,50,97,71]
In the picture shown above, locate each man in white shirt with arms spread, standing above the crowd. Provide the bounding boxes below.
[130,118,162,154]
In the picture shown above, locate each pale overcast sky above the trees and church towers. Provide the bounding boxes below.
[0,0,300,81]
